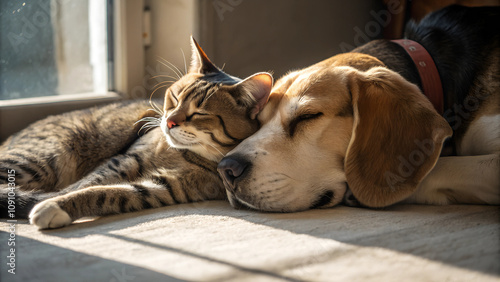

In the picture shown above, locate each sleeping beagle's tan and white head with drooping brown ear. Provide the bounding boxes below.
[219,53,451,212]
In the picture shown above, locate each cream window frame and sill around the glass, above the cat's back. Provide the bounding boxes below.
[0,0,145,142]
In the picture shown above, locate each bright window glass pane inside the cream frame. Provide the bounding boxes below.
[0,0,109,100]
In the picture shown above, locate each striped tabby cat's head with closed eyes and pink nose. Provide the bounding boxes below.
[161,38,273,161]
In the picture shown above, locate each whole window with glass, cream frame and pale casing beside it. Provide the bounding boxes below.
[0,0,188,142]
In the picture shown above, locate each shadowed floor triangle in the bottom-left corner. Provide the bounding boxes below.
[0,232,182,282]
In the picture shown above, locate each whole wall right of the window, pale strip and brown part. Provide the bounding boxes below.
[146,0,384,93]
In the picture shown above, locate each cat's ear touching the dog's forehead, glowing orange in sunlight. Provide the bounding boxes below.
[236,72,273,119]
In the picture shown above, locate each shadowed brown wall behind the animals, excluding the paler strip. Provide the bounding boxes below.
[200,0,383,77]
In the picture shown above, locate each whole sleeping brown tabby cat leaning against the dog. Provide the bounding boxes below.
[0,39,272,229]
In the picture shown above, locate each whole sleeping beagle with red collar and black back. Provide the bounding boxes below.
[218,6,500,212]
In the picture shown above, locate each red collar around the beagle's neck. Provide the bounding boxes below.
[391,39,444,115]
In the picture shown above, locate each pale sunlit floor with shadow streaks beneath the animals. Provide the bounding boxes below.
[0,201,500,282]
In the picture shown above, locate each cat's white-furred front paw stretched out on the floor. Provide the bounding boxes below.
[30,200,72,229]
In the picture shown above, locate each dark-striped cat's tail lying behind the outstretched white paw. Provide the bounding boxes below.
[0,185,55,219]
